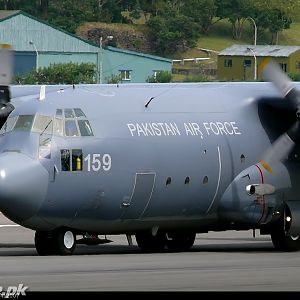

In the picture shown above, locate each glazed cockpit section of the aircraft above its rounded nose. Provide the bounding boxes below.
[0,108,93,159]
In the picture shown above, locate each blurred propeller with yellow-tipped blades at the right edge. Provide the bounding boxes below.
[260,59,300,173]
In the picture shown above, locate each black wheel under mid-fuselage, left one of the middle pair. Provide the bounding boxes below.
[135,231,167,252]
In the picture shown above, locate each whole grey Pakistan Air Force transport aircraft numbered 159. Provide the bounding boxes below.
[0,45,300,255]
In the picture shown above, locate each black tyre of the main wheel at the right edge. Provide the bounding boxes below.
[271,217,300,251]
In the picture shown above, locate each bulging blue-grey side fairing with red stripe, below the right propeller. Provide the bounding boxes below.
[218,163,290,226]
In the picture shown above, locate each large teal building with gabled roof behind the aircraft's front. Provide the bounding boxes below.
[0,10,172,83]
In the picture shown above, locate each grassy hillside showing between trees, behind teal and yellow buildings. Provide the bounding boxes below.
[76,20,300,81]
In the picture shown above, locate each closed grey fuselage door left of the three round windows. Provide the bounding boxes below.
[122,173,156,219]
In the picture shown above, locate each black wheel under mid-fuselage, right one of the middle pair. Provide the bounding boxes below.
[167,232,196,251]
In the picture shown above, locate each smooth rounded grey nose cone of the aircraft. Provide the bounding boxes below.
[0,152,49,223]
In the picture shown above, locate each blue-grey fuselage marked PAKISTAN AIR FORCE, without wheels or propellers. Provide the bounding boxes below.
[0,83,296,234]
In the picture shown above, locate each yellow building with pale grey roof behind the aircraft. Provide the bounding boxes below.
[217,45,300,81]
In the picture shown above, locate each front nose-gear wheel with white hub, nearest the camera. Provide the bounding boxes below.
[54,228,76,255]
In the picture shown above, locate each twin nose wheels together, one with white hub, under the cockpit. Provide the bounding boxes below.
[34,228,76,255]
